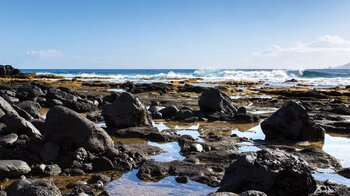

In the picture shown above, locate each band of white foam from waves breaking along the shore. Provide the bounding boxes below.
[32,69,350,86]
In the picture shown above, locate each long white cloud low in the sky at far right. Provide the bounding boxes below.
[252,35,350,57]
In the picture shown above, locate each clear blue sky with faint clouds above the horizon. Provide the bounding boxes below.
[0,0,350,69]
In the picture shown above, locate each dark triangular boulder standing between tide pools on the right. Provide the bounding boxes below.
[261,101,325,141]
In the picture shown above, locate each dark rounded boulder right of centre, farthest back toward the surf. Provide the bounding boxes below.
[198,88,237,116]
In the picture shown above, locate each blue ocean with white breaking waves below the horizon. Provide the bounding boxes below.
[23,69,350,87]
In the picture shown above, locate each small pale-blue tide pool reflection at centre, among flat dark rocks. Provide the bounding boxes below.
[148,142,185,162]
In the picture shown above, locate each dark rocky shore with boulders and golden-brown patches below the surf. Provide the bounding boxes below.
[0,66,350,196]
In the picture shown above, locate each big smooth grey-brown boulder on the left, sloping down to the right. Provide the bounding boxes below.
[44,106,114,152]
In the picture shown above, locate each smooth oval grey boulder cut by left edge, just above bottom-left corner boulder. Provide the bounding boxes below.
[0,160,31,179]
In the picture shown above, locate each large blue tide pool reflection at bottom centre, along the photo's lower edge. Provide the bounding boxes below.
[106,169,216,196]
